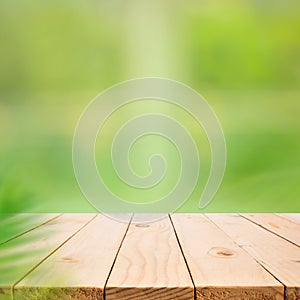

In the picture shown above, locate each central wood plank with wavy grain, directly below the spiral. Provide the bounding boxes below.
[105,216,194,300]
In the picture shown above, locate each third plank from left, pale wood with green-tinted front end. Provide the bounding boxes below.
[14,215,129,300]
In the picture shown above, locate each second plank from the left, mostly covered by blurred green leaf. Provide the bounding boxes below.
[0,214,95,299]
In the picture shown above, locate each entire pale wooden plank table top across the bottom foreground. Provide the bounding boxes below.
[0,214,300,300]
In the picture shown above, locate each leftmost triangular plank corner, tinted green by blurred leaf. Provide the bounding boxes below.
[0,213,60,245]
